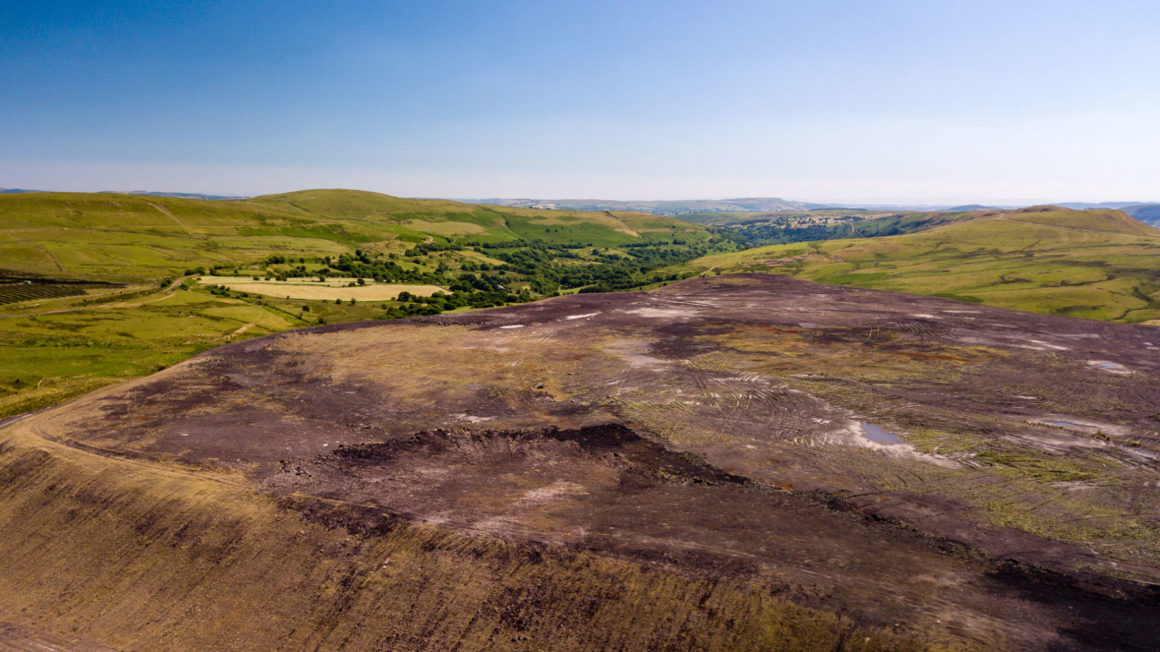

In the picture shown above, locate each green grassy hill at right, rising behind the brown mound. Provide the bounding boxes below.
[682,208,1160,321]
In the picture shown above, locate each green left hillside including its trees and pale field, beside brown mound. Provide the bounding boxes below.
[0,190,735,416]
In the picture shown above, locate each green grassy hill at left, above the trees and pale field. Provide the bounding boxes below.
[0,190,701,282]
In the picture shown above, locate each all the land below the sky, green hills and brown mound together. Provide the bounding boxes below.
[0,190,1160,650]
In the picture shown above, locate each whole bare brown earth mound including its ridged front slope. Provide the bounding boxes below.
[0,275,1160,650]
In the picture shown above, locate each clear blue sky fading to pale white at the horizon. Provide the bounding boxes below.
[0,0,1160,203]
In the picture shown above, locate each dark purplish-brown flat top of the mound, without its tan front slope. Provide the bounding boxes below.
[13,275,1160,649]
